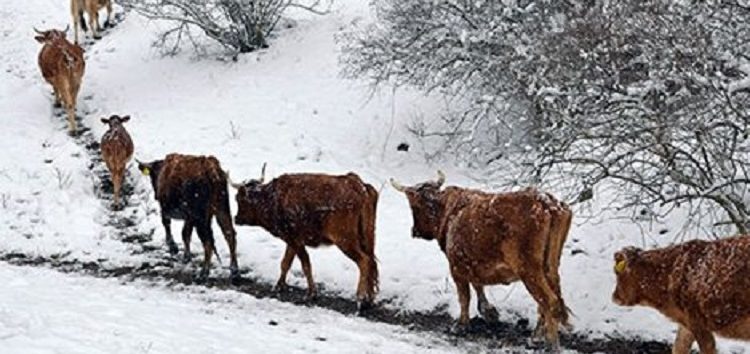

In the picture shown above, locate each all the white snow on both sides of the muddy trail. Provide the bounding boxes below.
[0,0,750,352]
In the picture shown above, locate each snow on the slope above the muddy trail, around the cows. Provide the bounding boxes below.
[0,0,750,351]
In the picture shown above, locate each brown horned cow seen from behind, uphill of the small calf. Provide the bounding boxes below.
[34,28,86,135]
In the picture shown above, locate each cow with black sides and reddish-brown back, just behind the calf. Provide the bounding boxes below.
[138,154,239,279]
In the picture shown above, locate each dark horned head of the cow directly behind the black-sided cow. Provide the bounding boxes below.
[227,163,267,226]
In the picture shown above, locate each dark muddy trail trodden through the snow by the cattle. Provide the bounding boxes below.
[0,13,670,354]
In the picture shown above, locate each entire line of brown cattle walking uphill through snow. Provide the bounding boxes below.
[27,0,750,353]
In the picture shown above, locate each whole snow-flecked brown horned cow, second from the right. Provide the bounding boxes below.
[391,171,573,350]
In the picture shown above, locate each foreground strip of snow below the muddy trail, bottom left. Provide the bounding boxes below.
[0,265,463,354]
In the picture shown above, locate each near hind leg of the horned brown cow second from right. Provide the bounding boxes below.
[521,274,561,352]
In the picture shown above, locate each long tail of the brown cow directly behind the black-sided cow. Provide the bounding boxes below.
[359,184,380,296]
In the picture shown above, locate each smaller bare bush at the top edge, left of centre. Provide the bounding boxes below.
[123,0,331,54]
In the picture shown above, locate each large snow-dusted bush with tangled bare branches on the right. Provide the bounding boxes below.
[342,0,750,232]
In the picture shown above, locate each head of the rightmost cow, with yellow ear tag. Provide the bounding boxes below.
[612,247,643,306]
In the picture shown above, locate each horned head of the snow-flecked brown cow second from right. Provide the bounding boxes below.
[391,171,445,240]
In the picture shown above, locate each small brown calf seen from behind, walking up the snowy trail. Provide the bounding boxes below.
[101,115,133,209]
